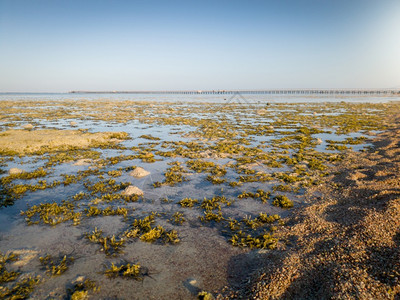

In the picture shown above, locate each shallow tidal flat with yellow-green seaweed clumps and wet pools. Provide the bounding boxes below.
[0,99,400,299]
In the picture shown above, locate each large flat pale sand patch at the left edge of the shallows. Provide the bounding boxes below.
[0,129,129,154]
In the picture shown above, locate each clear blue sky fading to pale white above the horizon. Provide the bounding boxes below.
[0,0,400,92]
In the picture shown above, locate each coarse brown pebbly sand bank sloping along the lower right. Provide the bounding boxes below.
[218,117,400,299]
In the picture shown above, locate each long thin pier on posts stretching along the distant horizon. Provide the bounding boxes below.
[70,89,400,95]
